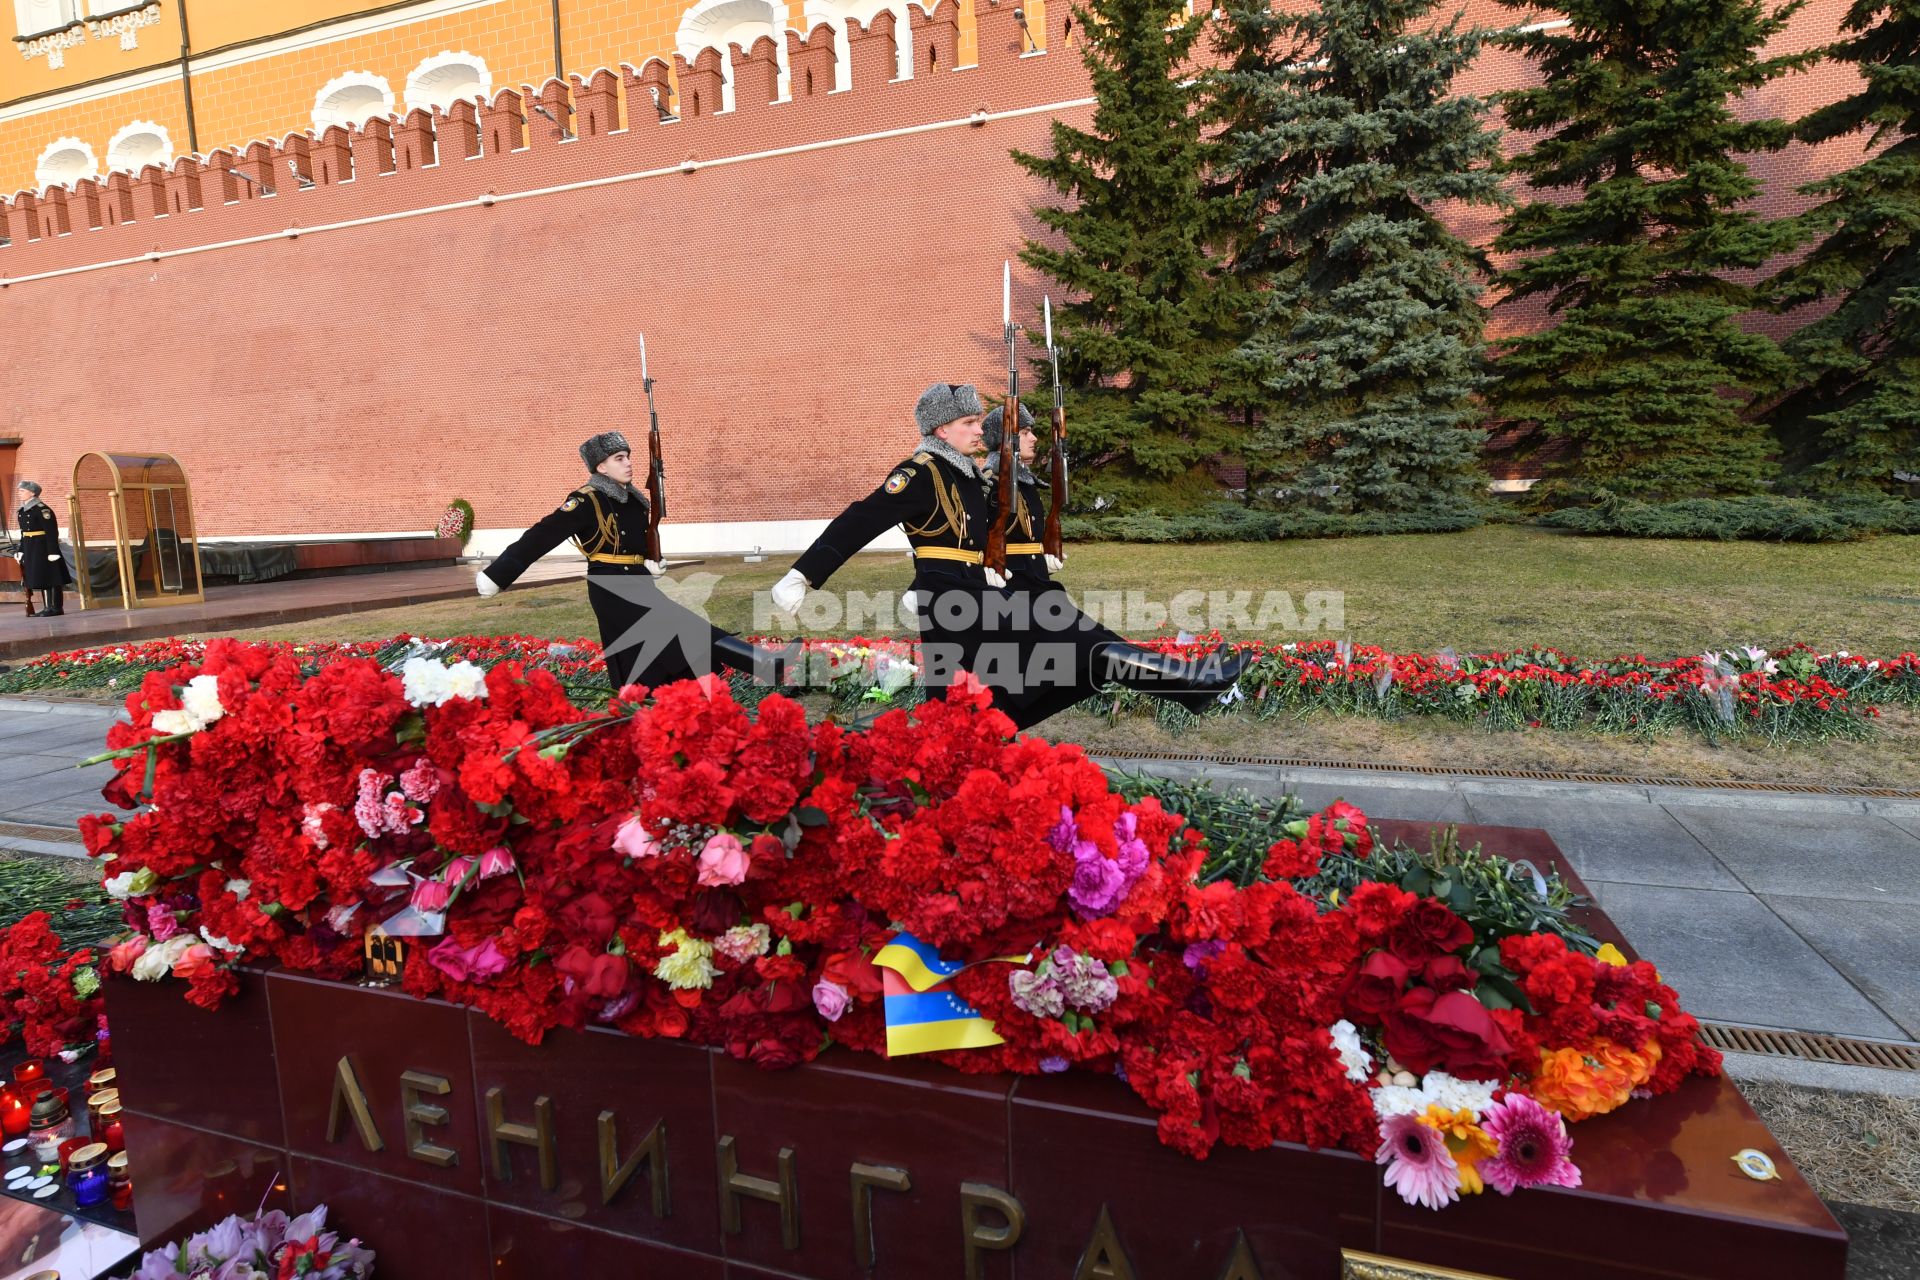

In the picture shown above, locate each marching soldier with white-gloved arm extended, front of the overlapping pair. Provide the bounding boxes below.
[772,382,1002,702]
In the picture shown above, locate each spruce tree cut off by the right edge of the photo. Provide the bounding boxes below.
[1774,0,1920,493]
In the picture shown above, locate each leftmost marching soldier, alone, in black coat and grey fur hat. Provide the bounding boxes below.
[474,432,793,691]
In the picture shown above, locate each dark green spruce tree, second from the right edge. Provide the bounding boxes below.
[1494,0,1807,501]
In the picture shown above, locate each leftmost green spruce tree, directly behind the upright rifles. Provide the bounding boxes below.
[1014,0,1244,509]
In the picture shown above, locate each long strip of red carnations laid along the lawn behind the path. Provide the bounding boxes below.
[0,635,1920,741]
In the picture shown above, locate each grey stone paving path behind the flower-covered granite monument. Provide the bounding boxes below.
[0,699,1920,1040]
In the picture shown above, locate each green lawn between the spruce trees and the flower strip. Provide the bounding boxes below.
[228,526,1920,656]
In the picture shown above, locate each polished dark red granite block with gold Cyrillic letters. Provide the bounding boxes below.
[108,821,1845,1280]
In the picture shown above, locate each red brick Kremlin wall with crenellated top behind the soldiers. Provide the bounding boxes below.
[0,0,1859,551]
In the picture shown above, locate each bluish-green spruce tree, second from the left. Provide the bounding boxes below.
[1212,0,1501,512]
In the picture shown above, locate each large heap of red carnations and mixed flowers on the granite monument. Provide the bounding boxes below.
[83,641,1718,1207]
